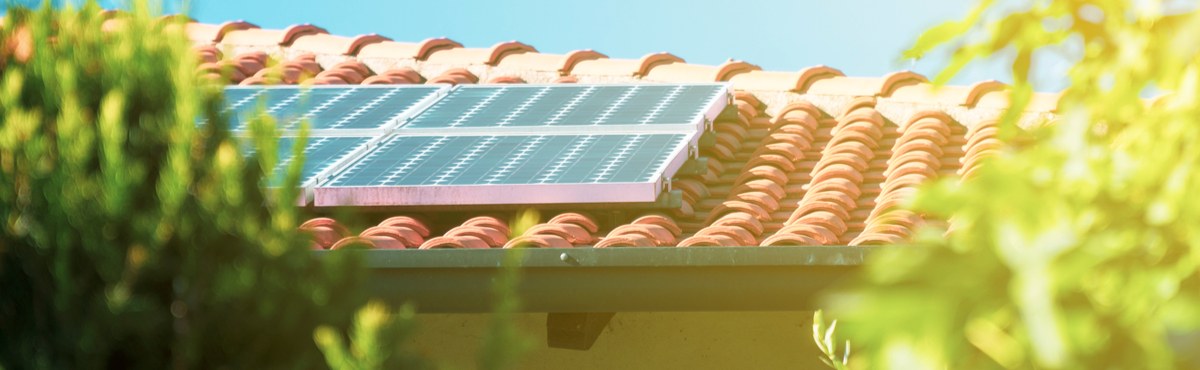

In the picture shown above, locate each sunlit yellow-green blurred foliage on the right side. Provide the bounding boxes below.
[834,0,1200,369]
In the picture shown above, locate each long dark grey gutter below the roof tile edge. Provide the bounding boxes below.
[333,246,875,314]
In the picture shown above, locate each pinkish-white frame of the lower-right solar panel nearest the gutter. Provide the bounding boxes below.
[313,132,700,207]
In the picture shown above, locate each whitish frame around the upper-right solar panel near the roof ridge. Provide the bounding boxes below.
[396,83,733,135]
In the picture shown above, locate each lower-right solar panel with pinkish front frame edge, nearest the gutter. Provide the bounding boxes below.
[314,133,695,205]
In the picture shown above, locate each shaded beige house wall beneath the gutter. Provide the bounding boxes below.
[412,312,824,370]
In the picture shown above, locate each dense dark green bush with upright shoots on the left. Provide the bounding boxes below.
[0,1,374,369]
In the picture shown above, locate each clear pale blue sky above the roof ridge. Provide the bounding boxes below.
[11,0,1060,88]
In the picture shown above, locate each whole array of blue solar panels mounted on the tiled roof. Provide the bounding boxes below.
[226,84,728,207]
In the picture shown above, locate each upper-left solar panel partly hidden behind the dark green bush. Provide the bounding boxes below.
[226,85,448,135]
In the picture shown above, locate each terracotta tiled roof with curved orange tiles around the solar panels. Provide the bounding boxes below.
[187,22,1057,249]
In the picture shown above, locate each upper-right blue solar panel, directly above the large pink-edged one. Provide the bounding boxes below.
[400,84,727,133]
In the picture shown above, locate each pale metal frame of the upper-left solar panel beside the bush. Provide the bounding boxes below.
[224,84,454,137]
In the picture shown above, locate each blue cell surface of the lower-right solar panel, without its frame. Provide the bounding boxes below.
[323,135,688,187]
